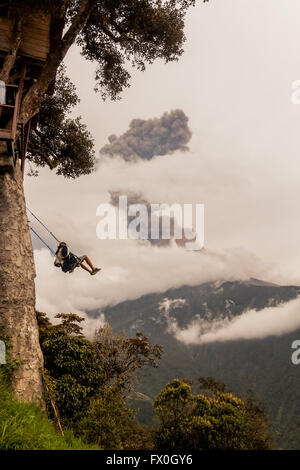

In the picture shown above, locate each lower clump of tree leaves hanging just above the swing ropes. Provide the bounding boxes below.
[28,67,95,178]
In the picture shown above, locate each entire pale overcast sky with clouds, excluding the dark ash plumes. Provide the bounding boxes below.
[25,0,300,324]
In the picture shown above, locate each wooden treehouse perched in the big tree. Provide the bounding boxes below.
[0,0,62,172]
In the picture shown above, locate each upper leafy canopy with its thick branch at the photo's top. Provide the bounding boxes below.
[5,0,209,130]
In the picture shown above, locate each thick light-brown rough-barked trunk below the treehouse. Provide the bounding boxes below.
[0,156,43,404]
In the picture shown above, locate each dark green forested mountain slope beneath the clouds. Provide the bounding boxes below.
[90,280,300,449]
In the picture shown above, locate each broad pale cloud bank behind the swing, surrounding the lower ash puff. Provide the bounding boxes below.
[27,144,298,324]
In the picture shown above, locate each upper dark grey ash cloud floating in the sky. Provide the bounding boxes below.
[100,109,192,161]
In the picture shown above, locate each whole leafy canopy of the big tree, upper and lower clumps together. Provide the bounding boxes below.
[15,0,206,174]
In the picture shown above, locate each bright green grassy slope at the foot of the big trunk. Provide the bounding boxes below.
[0,368,99,450]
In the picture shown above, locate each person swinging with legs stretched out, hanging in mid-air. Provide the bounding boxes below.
[54,242,101,276]
